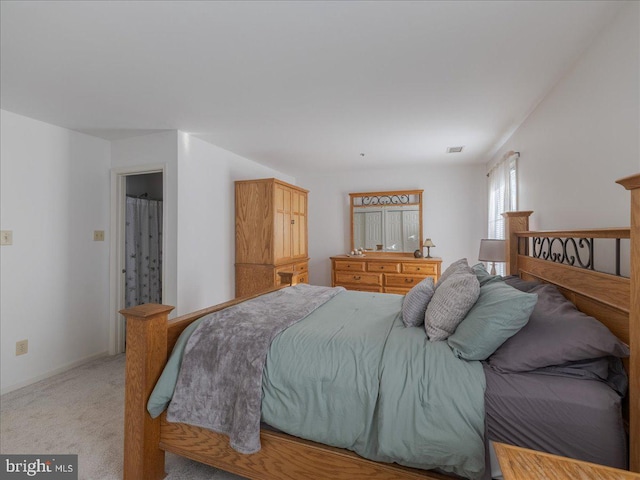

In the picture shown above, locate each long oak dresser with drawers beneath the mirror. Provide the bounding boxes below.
[331,253,442,295]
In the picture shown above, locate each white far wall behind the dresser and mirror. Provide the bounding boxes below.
[296,165,487,285]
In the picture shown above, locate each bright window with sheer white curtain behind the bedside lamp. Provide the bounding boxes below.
[487,152,520,275]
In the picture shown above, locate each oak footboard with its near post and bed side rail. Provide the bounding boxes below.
[121,287,451,480]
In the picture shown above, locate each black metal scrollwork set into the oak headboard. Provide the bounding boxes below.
[531,237,594,270]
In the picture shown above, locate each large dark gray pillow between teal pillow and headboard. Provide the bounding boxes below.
[489,284,629,373]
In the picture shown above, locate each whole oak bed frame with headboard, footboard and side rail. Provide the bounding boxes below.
[121,174,640,480]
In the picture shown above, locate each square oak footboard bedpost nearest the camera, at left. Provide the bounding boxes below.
[120,304,173,480]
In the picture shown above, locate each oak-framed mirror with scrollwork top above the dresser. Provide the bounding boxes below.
[349,190,423,252]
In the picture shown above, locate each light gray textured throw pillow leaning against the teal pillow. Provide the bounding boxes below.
[424,266,480,342]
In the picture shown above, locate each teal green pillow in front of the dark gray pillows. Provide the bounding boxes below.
[447,281,538,360]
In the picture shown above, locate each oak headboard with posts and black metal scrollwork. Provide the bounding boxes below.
[503,174,640,472]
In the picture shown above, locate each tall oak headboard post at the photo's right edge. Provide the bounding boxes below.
[616,174,640,472]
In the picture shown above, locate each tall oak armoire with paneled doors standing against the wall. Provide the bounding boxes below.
[235,178,309,297]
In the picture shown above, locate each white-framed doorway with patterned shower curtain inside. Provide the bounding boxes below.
[109,167,165,354]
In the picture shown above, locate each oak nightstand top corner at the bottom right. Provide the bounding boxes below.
[493,442,640,480]
